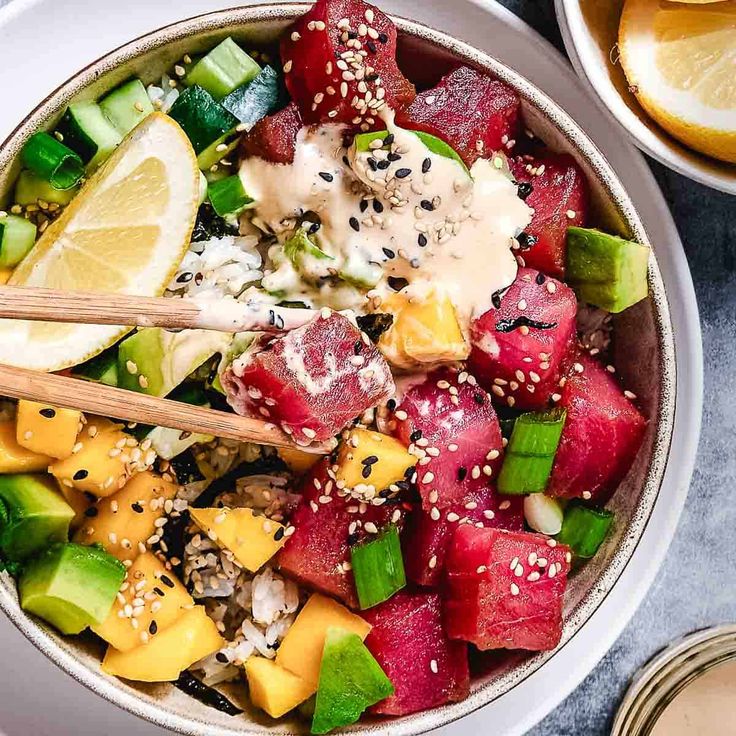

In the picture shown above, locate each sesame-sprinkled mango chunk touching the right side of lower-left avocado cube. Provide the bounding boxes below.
[92,552,194,652]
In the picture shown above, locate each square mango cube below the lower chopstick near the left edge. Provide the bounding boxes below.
[15,400,82,459]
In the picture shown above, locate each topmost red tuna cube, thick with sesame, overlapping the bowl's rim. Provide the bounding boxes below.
[281,0,416,130]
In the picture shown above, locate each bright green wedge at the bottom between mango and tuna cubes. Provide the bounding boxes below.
[312,626,394,734]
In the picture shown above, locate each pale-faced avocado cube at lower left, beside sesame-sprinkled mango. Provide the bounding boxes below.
[18,542,125,634]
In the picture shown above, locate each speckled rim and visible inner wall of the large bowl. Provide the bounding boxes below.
[0,4,675,735]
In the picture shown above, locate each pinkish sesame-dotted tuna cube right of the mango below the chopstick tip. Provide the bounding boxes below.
[395,370,503,508]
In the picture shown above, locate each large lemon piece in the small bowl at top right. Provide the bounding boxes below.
[619,0,736,163]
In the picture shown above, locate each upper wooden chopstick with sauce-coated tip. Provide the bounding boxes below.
[0,286,316,332]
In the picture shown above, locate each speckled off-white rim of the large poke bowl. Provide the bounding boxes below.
[0,0,677,736]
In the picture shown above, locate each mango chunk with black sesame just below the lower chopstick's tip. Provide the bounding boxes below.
[335,429,417,491]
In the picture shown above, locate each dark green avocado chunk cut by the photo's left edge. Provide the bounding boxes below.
[0,473,74,561]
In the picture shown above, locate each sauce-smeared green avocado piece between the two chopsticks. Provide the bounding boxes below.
[118,327,231,396]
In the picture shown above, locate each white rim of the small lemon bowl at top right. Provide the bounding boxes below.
[555,0,736,194]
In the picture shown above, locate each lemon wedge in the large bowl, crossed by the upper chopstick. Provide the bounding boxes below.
[0,113,199,371]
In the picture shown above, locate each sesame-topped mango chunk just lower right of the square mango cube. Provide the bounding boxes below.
[50,421,138,498]
